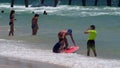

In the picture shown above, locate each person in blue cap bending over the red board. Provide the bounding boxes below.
[53,29,76,53]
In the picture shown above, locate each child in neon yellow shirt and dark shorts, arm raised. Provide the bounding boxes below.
[84,25,97,57]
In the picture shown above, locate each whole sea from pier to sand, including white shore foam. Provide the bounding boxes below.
[0,0,120,68]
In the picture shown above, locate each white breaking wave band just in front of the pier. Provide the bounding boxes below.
[0,3,120,17]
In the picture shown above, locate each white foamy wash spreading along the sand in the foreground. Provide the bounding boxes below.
[0,39,120,68]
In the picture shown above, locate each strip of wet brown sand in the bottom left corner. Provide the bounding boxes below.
[0,57,69,68]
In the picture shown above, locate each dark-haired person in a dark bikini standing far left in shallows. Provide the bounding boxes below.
[9,10,16,36]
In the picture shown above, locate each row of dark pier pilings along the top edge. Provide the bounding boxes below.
[11,0,120,7]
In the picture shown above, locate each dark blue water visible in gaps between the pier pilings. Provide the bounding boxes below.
[1,0,119,6]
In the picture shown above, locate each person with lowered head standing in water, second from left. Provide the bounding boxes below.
[31,14,39,35]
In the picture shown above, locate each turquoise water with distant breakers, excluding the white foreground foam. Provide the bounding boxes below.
[0,5,120,58]
